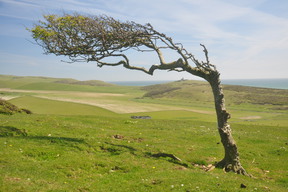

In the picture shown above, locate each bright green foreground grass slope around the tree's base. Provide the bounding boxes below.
[0,114,288,192]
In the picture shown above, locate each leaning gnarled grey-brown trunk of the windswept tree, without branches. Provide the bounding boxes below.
[206,71,248,175]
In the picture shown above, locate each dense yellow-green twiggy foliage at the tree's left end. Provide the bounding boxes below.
[28,14,151,57]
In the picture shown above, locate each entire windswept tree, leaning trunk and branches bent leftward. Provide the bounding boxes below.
[29,14,248,175]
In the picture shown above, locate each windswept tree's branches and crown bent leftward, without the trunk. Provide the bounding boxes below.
[30,14,216,79]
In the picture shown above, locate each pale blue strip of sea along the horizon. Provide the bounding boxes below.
[109,78,288,89]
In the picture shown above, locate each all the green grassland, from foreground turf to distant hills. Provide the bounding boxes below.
[0,75,288,192]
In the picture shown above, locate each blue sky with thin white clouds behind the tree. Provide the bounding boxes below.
[0,0,288,81]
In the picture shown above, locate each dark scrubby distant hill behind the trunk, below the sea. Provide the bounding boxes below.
[141,80,288,107]
